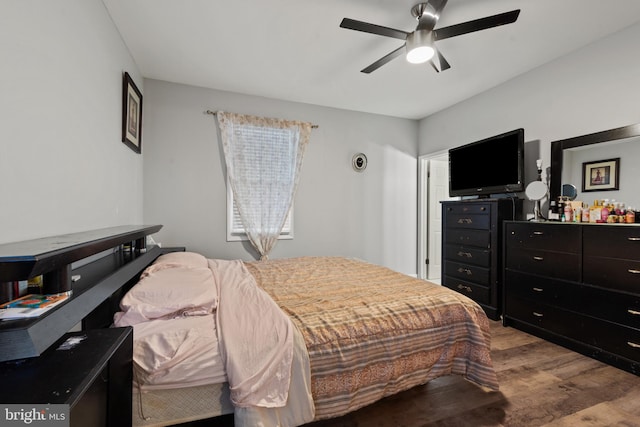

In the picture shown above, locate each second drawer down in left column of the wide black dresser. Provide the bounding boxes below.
[505,248,582,282]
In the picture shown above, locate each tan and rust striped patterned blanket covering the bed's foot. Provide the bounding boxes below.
[245,257,498,420]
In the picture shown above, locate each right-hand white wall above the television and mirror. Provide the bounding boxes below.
[419,24,640,202]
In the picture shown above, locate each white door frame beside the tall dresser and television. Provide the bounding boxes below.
[417,150,449,280]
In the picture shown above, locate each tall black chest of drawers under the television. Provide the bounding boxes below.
[442,199,522,320]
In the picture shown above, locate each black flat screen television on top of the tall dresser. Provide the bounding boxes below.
[449,129,524,197]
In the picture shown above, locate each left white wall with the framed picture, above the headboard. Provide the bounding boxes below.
[0,0,144,243]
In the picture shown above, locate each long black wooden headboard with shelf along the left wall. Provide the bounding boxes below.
[0,225,166,361]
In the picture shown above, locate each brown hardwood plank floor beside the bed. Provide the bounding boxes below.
[307,321,640,427]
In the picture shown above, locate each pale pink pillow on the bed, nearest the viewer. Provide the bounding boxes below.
[115,267,218,326]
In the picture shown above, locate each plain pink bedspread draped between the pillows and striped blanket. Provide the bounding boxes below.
[209,259,293,408]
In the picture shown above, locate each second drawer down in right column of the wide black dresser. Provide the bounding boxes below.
[584,256,640,294]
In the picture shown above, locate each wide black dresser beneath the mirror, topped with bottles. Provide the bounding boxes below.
[503,221,640,374]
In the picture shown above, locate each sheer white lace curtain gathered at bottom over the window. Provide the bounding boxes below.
[216,111,311,259]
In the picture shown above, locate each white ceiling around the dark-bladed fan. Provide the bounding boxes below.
[103,0,640,119]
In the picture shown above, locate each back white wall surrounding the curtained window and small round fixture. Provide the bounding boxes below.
[143,79,418,274]
